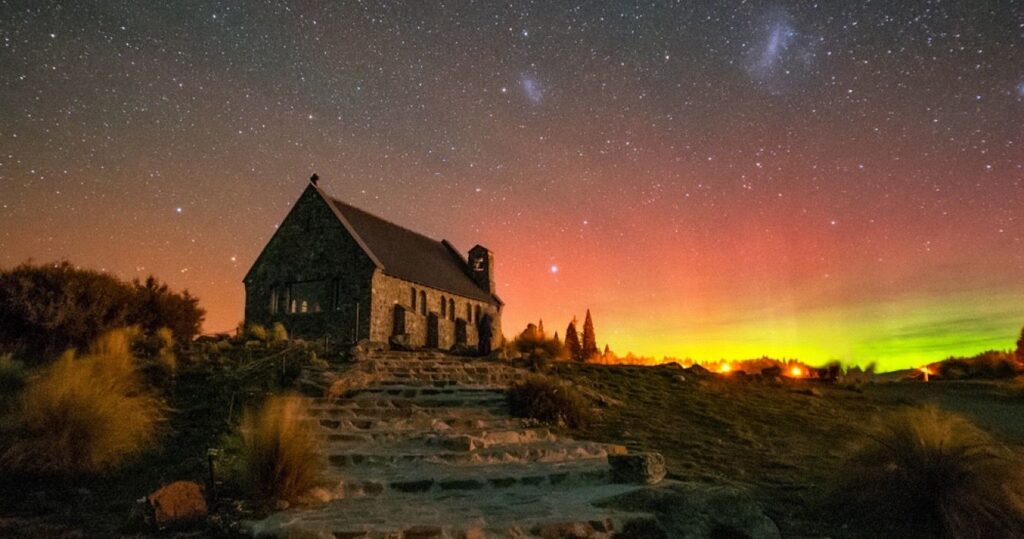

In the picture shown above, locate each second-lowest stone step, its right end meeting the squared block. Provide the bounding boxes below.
[329,458,609,498]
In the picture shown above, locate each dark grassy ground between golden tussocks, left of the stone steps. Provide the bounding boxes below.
[0,346,331,537]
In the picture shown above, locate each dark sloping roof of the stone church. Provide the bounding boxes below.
[316,188,501,304]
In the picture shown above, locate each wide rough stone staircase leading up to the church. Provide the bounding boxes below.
[243,351,651,539]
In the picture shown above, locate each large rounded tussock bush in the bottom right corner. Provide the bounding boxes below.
[836,406,1024,537]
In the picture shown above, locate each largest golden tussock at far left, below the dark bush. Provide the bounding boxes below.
[0,330,165,476]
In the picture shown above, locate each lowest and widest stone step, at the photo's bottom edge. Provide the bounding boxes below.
[244,484,648,539]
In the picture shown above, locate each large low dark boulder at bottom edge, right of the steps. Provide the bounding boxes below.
[595,481,781,539]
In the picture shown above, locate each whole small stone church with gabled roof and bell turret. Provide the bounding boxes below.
[244,174,503,350]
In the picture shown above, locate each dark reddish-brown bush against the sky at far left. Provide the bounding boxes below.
[0,262,205,362]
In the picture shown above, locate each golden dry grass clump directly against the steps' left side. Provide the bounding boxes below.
[241,396,324,501]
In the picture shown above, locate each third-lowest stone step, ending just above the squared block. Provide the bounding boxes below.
[326,442,624,467]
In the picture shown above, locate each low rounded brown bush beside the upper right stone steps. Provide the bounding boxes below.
[508,375,593,428]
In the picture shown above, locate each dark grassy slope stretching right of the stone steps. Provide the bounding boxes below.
[555,364,1024,537]
